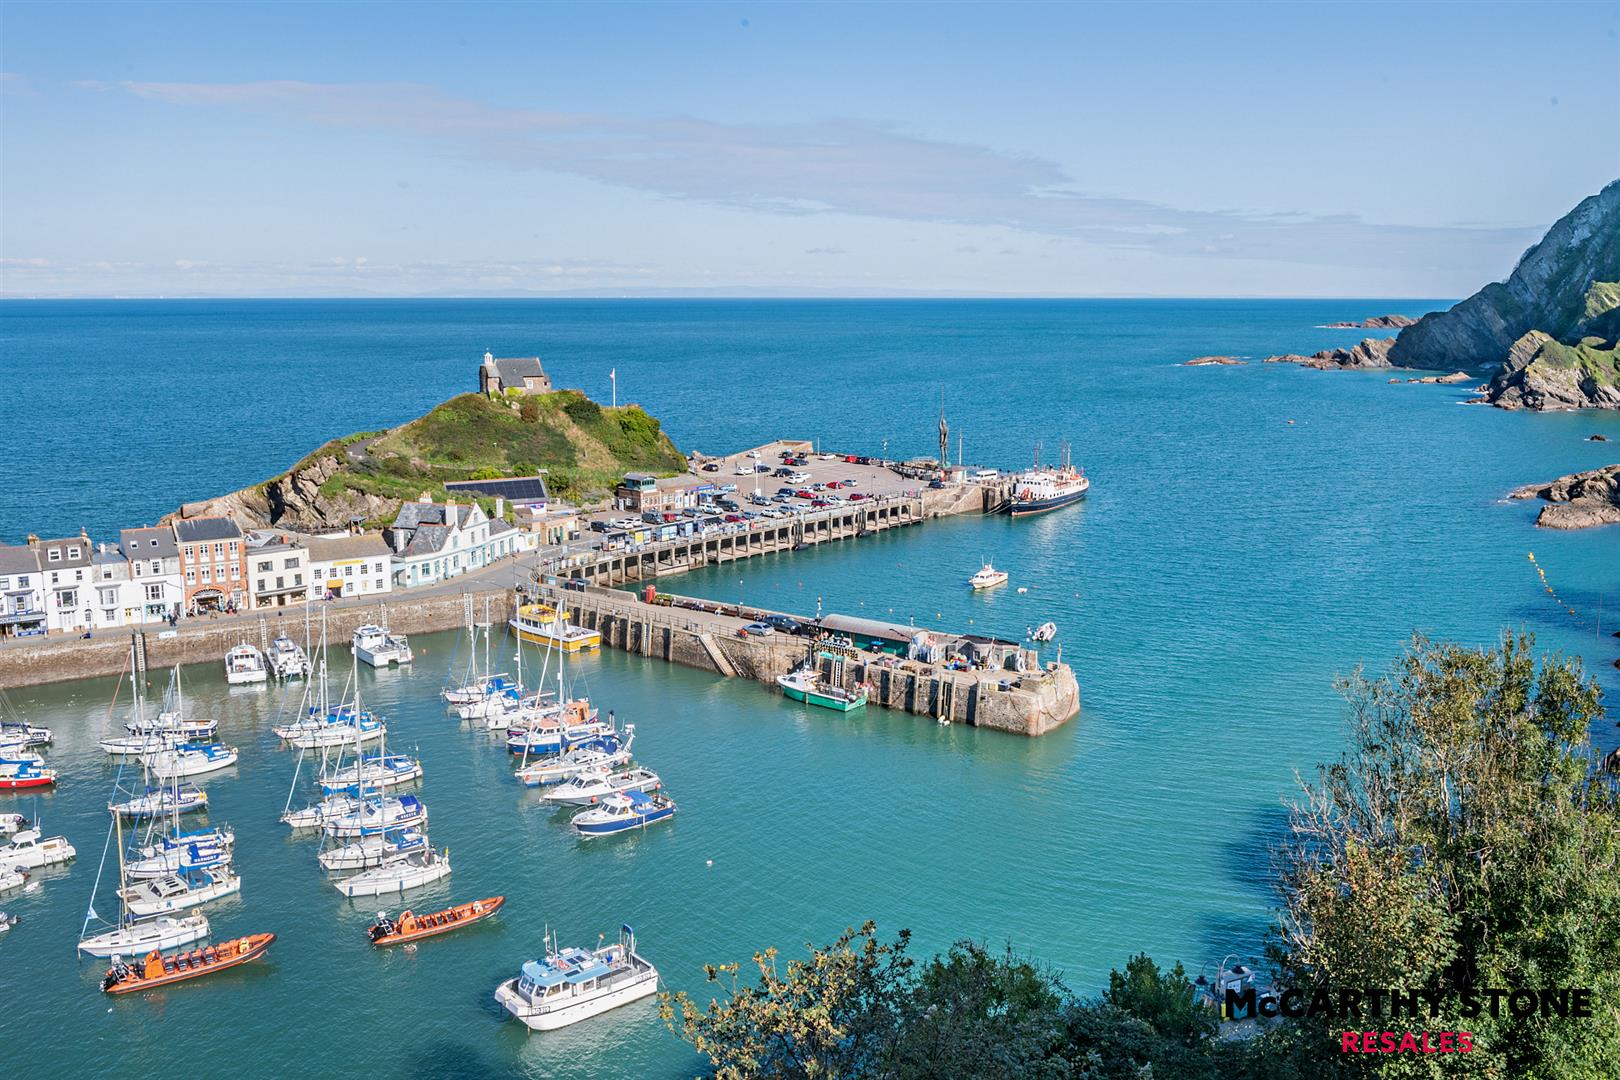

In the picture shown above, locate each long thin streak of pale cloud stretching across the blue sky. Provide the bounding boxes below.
[122,81,1536,269]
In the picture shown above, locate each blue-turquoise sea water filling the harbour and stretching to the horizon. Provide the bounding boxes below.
[0,301,1620,1078]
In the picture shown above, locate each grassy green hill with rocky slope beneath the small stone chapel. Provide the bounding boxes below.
[275,390,685,523]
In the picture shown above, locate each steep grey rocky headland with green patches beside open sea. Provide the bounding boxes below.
[1388,180,1620,408]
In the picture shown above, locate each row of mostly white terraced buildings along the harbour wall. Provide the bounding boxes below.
[0,478,578,638]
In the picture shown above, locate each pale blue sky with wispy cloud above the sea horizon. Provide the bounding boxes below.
[0,0,1620,298]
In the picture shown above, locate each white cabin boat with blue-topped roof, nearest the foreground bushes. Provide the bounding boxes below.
[496,926,658,1031]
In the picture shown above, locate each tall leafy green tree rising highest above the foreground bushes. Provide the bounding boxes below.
[1270,635,1620,1080]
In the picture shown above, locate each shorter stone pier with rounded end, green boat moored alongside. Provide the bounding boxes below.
[527,585,1081,735]
